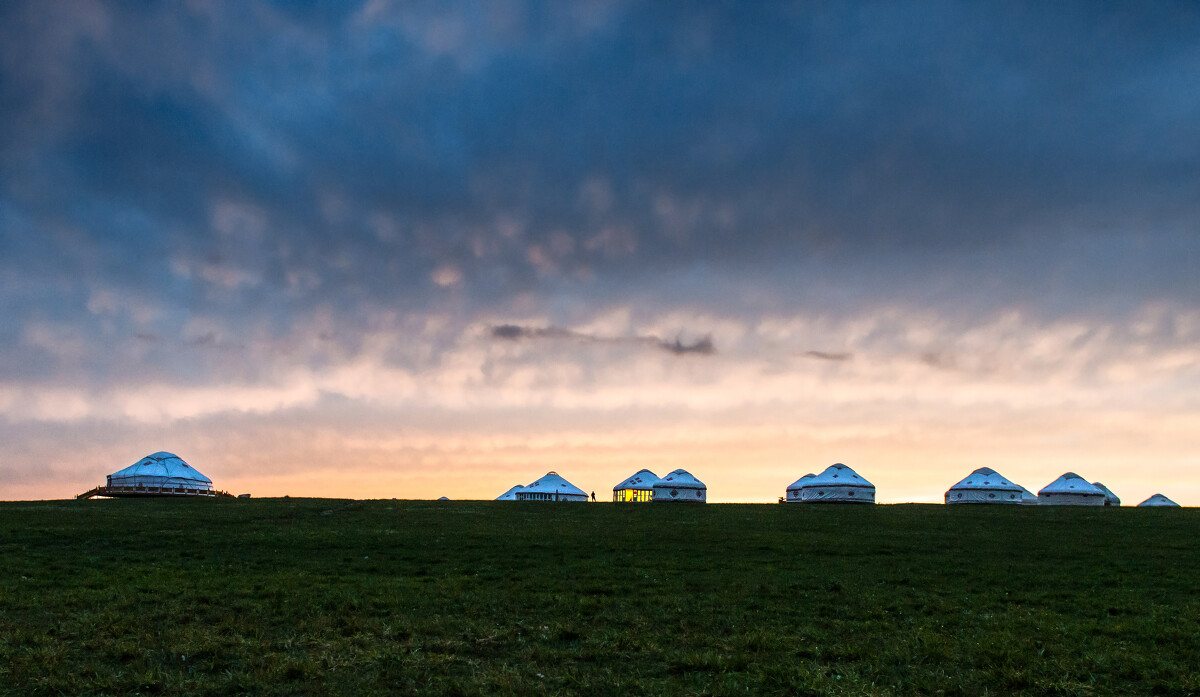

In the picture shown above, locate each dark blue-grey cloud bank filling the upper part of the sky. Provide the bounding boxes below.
[0,1,1200,381]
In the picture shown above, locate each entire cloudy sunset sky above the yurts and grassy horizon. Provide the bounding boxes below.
[0,0,1200,505]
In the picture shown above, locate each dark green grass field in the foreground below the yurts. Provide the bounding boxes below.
[0,499,1200,695]
